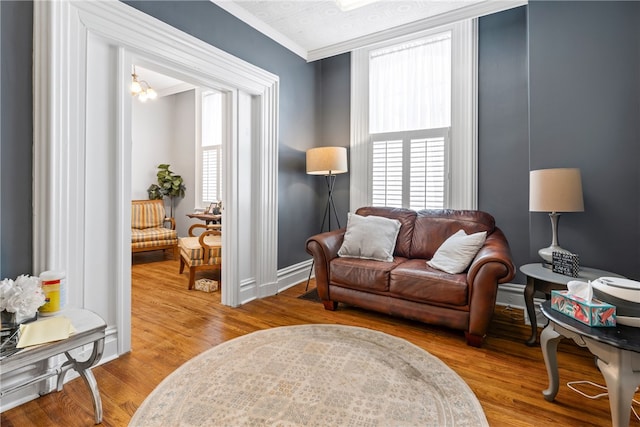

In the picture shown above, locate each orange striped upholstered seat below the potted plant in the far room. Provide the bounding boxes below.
[131,200,178,254]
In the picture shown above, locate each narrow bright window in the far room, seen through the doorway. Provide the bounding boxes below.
[198,91,223,207]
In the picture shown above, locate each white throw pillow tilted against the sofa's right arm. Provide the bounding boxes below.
[427,230,487,274]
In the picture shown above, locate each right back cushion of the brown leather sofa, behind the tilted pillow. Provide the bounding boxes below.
[407,209,495,259]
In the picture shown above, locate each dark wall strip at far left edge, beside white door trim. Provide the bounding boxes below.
[0,1,33,278]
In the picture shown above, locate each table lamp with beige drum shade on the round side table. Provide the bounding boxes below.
[529,168,584,265]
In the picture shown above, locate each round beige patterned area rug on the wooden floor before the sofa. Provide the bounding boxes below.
[129,325,488,427]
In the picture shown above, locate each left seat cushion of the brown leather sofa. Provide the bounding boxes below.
[329,257,406,292]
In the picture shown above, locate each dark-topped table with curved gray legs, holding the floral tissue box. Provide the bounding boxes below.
[540,301,640,427]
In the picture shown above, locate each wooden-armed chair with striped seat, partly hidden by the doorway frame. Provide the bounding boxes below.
[178,224,222,289]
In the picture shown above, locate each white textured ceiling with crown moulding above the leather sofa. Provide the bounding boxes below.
[211,0,526,60]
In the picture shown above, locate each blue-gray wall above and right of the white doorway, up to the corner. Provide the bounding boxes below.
[126,1,321,268]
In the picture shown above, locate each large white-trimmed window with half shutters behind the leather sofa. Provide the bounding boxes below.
[351,21,477,209]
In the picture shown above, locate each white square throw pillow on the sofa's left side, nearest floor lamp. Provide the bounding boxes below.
[338,212,400,262]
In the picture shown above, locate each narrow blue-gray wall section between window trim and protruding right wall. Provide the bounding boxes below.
[478,6,529,283]
